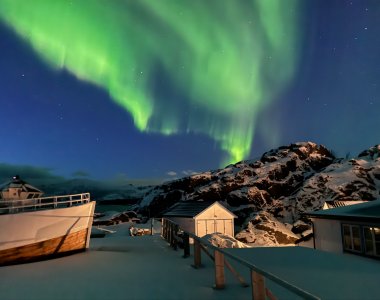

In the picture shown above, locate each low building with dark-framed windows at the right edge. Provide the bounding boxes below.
[306,200,380,258]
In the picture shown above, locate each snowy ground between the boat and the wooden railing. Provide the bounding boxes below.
[0,235,251,300]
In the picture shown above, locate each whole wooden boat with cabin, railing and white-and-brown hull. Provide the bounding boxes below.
[0,176,95,265]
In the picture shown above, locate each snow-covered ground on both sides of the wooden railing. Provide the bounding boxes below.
[0,223,380,300]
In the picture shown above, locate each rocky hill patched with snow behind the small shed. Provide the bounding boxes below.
[140,142,380,245]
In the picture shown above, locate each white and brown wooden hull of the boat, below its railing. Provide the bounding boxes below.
[0,202,95,265]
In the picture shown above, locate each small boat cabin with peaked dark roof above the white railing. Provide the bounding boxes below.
[0,175,43,201]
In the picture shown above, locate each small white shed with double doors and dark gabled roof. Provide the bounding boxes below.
[163,201,236,237]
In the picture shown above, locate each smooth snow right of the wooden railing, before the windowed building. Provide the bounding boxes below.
[225,247,380,300]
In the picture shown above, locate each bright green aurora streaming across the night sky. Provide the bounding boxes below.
[0,0,301,164]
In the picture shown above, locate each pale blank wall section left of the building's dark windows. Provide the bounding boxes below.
[313,219,343,253]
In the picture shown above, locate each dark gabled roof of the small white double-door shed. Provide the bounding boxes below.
[163,201,236,218]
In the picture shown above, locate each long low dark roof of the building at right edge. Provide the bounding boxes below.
[306,200,380,222]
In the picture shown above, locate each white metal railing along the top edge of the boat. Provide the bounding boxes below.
[0,193,90,214]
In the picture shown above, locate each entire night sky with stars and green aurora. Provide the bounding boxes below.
[0,0,380,182]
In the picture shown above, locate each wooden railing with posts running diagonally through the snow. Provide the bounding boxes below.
[162,219,320,300]
